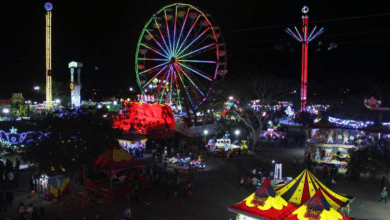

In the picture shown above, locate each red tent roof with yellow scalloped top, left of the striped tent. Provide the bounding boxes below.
[228,178,297,220]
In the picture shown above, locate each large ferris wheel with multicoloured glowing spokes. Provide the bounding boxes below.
[135,3,228,115]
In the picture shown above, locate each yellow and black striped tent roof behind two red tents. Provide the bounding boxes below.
[275,169,353,212]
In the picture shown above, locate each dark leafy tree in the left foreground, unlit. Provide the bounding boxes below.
[23,108,120,194]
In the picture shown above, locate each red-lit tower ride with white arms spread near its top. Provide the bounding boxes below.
[286,5,324,112]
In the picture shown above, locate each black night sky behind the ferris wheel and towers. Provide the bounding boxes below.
[0,0,390,99]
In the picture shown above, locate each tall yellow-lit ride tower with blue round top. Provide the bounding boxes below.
[45,2,53,110]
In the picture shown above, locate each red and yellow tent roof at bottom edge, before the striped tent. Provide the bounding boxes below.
[285,188,354,220]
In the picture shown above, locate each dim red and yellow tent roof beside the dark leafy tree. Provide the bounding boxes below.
[92,143,145,175]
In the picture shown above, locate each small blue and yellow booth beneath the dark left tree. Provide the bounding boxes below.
[38,166,70,200]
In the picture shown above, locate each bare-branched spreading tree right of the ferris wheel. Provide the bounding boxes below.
[215,73,297,148]
